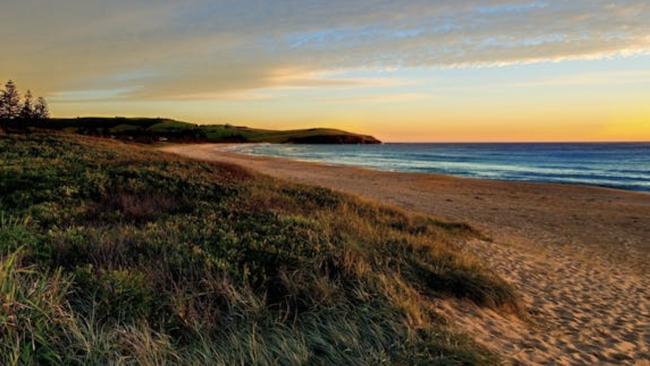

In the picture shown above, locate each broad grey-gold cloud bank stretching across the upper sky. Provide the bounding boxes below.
[0,0,650,100]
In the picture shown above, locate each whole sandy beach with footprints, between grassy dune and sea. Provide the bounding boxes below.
[161,144,650,365]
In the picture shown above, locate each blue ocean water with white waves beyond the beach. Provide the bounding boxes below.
[228,143,650,192]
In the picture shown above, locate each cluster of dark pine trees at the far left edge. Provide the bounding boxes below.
[0,80,50,120]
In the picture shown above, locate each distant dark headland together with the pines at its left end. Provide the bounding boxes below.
[0,80,381,144]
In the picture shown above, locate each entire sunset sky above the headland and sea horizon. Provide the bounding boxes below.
[0,0,650,142]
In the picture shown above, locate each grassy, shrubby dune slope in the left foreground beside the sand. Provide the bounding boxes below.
[0,131,518,365]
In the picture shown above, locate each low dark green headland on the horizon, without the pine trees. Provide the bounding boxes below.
[33,118,380,144]
